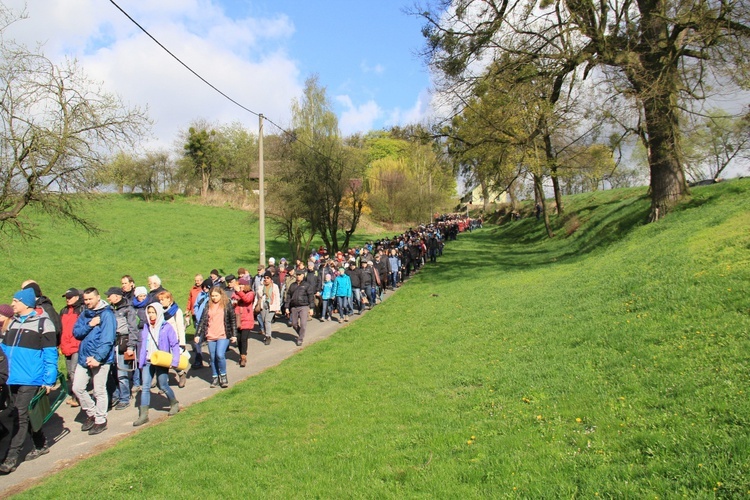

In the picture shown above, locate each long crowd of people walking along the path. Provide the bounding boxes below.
[0,216,475,474]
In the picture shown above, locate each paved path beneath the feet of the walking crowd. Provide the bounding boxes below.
[0,291,393,498]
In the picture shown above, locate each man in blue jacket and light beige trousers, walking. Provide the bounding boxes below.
[73,287,117,435]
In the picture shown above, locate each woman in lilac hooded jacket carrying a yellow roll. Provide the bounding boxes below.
[133,302,180,427]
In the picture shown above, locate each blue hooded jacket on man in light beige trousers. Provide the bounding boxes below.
[73,299,117,368]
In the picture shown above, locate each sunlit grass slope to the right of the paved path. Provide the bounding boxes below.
[7,180,750,498]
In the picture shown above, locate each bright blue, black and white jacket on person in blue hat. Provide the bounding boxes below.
[1,309,57,387]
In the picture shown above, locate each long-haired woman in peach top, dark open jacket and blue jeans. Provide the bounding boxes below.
[195,286,237,388]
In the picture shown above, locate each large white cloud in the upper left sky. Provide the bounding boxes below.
[6,0,302,148]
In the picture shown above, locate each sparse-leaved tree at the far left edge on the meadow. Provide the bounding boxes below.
[0,11,150,235]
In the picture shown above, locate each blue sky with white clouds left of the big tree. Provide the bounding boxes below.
[4,0,440,149]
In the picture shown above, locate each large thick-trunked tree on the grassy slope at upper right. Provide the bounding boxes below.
[417,0,750,220]
